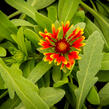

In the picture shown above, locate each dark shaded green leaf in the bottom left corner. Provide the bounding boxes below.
[0,96,20,109]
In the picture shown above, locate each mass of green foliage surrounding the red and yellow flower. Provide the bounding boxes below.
[0,0,109,109]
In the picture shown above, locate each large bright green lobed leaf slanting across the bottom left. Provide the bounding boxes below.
[0,59,49,109]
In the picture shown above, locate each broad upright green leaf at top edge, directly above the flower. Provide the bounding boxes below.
[58,0,81,23]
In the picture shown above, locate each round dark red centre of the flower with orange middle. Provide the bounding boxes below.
[55,39,70,53]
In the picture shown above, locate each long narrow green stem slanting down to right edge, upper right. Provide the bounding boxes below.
[81,1,109,26]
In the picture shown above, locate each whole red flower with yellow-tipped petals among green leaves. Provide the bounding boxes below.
[39,21,85,69]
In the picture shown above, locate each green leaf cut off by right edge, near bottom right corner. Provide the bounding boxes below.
[99,83,109,106]
